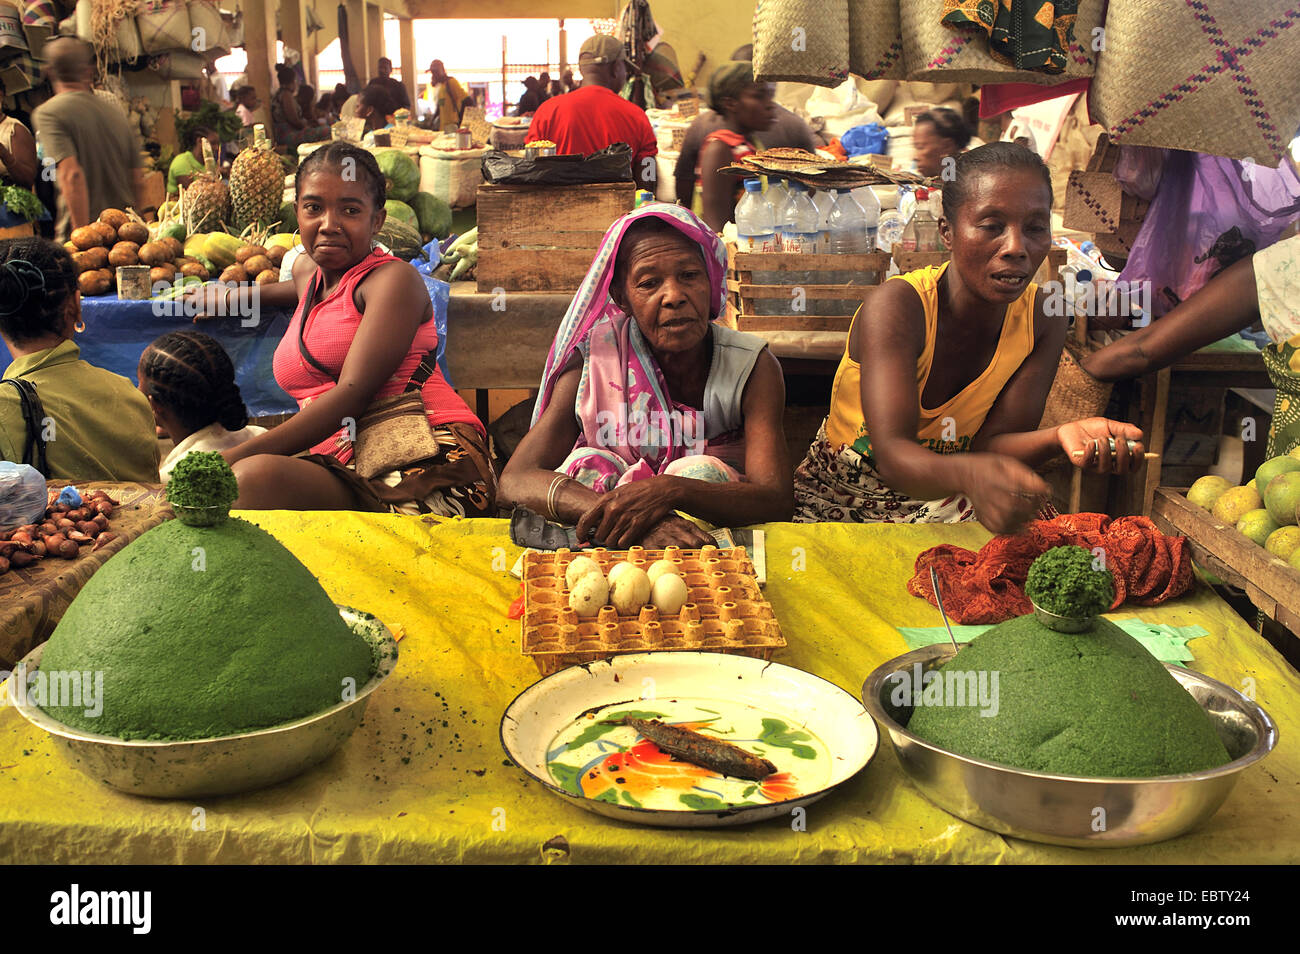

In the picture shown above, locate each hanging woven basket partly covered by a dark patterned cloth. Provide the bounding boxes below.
[898,0,1102,86]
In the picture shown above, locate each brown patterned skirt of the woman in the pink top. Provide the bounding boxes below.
[303,424,497,517]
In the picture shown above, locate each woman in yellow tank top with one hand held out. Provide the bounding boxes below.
[794,143,1143,533]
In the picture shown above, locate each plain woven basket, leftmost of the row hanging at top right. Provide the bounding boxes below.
[754,0,849,87]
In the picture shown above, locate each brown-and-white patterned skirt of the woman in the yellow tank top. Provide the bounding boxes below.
[794,421,975,524]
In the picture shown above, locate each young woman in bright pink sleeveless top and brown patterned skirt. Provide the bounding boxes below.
[210,143,497,516]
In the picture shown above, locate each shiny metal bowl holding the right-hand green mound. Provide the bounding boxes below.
[862,643,1278,847]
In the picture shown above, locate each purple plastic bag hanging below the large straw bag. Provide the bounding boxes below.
[1119,151,1300,318]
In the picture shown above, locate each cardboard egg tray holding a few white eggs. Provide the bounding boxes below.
[521,547,785,676]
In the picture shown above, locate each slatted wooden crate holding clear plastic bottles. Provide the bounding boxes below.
[727,243,889,331]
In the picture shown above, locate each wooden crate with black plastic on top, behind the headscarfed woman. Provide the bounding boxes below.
[477,182,636,294]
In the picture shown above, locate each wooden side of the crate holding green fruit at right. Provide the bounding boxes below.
[1151,487,1300,633]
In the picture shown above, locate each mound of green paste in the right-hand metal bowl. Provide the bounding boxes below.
[907,616,1231,779]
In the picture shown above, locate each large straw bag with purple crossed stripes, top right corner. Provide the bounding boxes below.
[1089,0,1300,166]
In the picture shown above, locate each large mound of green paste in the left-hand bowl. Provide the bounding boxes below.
[40,520,372,740]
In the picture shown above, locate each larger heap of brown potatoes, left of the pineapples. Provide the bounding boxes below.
[64,209,212,295]
